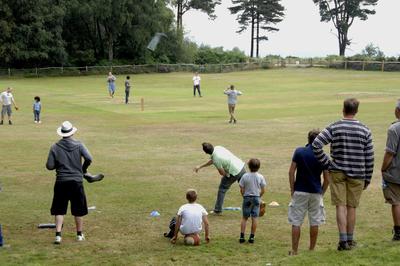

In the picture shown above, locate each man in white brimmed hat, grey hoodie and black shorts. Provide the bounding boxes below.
[46,121,92,244]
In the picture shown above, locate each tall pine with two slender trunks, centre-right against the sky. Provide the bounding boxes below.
[229,0,284,57]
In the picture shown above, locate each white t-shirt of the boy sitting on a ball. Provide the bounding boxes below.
[178,203,208,235]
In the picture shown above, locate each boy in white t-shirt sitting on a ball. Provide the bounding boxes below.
[171,189,210,244]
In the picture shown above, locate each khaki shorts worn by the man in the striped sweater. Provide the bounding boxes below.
[329,171,364,208]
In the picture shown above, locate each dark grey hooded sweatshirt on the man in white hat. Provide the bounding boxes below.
[46,137,92,182]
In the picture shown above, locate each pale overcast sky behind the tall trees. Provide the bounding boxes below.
[183,0,400,57]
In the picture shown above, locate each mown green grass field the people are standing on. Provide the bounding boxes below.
[0,69,400,265]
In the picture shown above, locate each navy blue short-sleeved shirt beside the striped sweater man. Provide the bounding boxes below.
[292,145,324,193]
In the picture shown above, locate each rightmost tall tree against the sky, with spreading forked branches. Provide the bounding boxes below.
[313,0,378,56]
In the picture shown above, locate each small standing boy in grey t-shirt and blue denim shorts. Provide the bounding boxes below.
[239,159,266,243]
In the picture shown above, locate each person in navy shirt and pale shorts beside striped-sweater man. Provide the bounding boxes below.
[288,130,329,255]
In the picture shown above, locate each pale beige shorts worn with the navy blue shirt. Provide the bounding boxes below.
[288,191,325,226]
